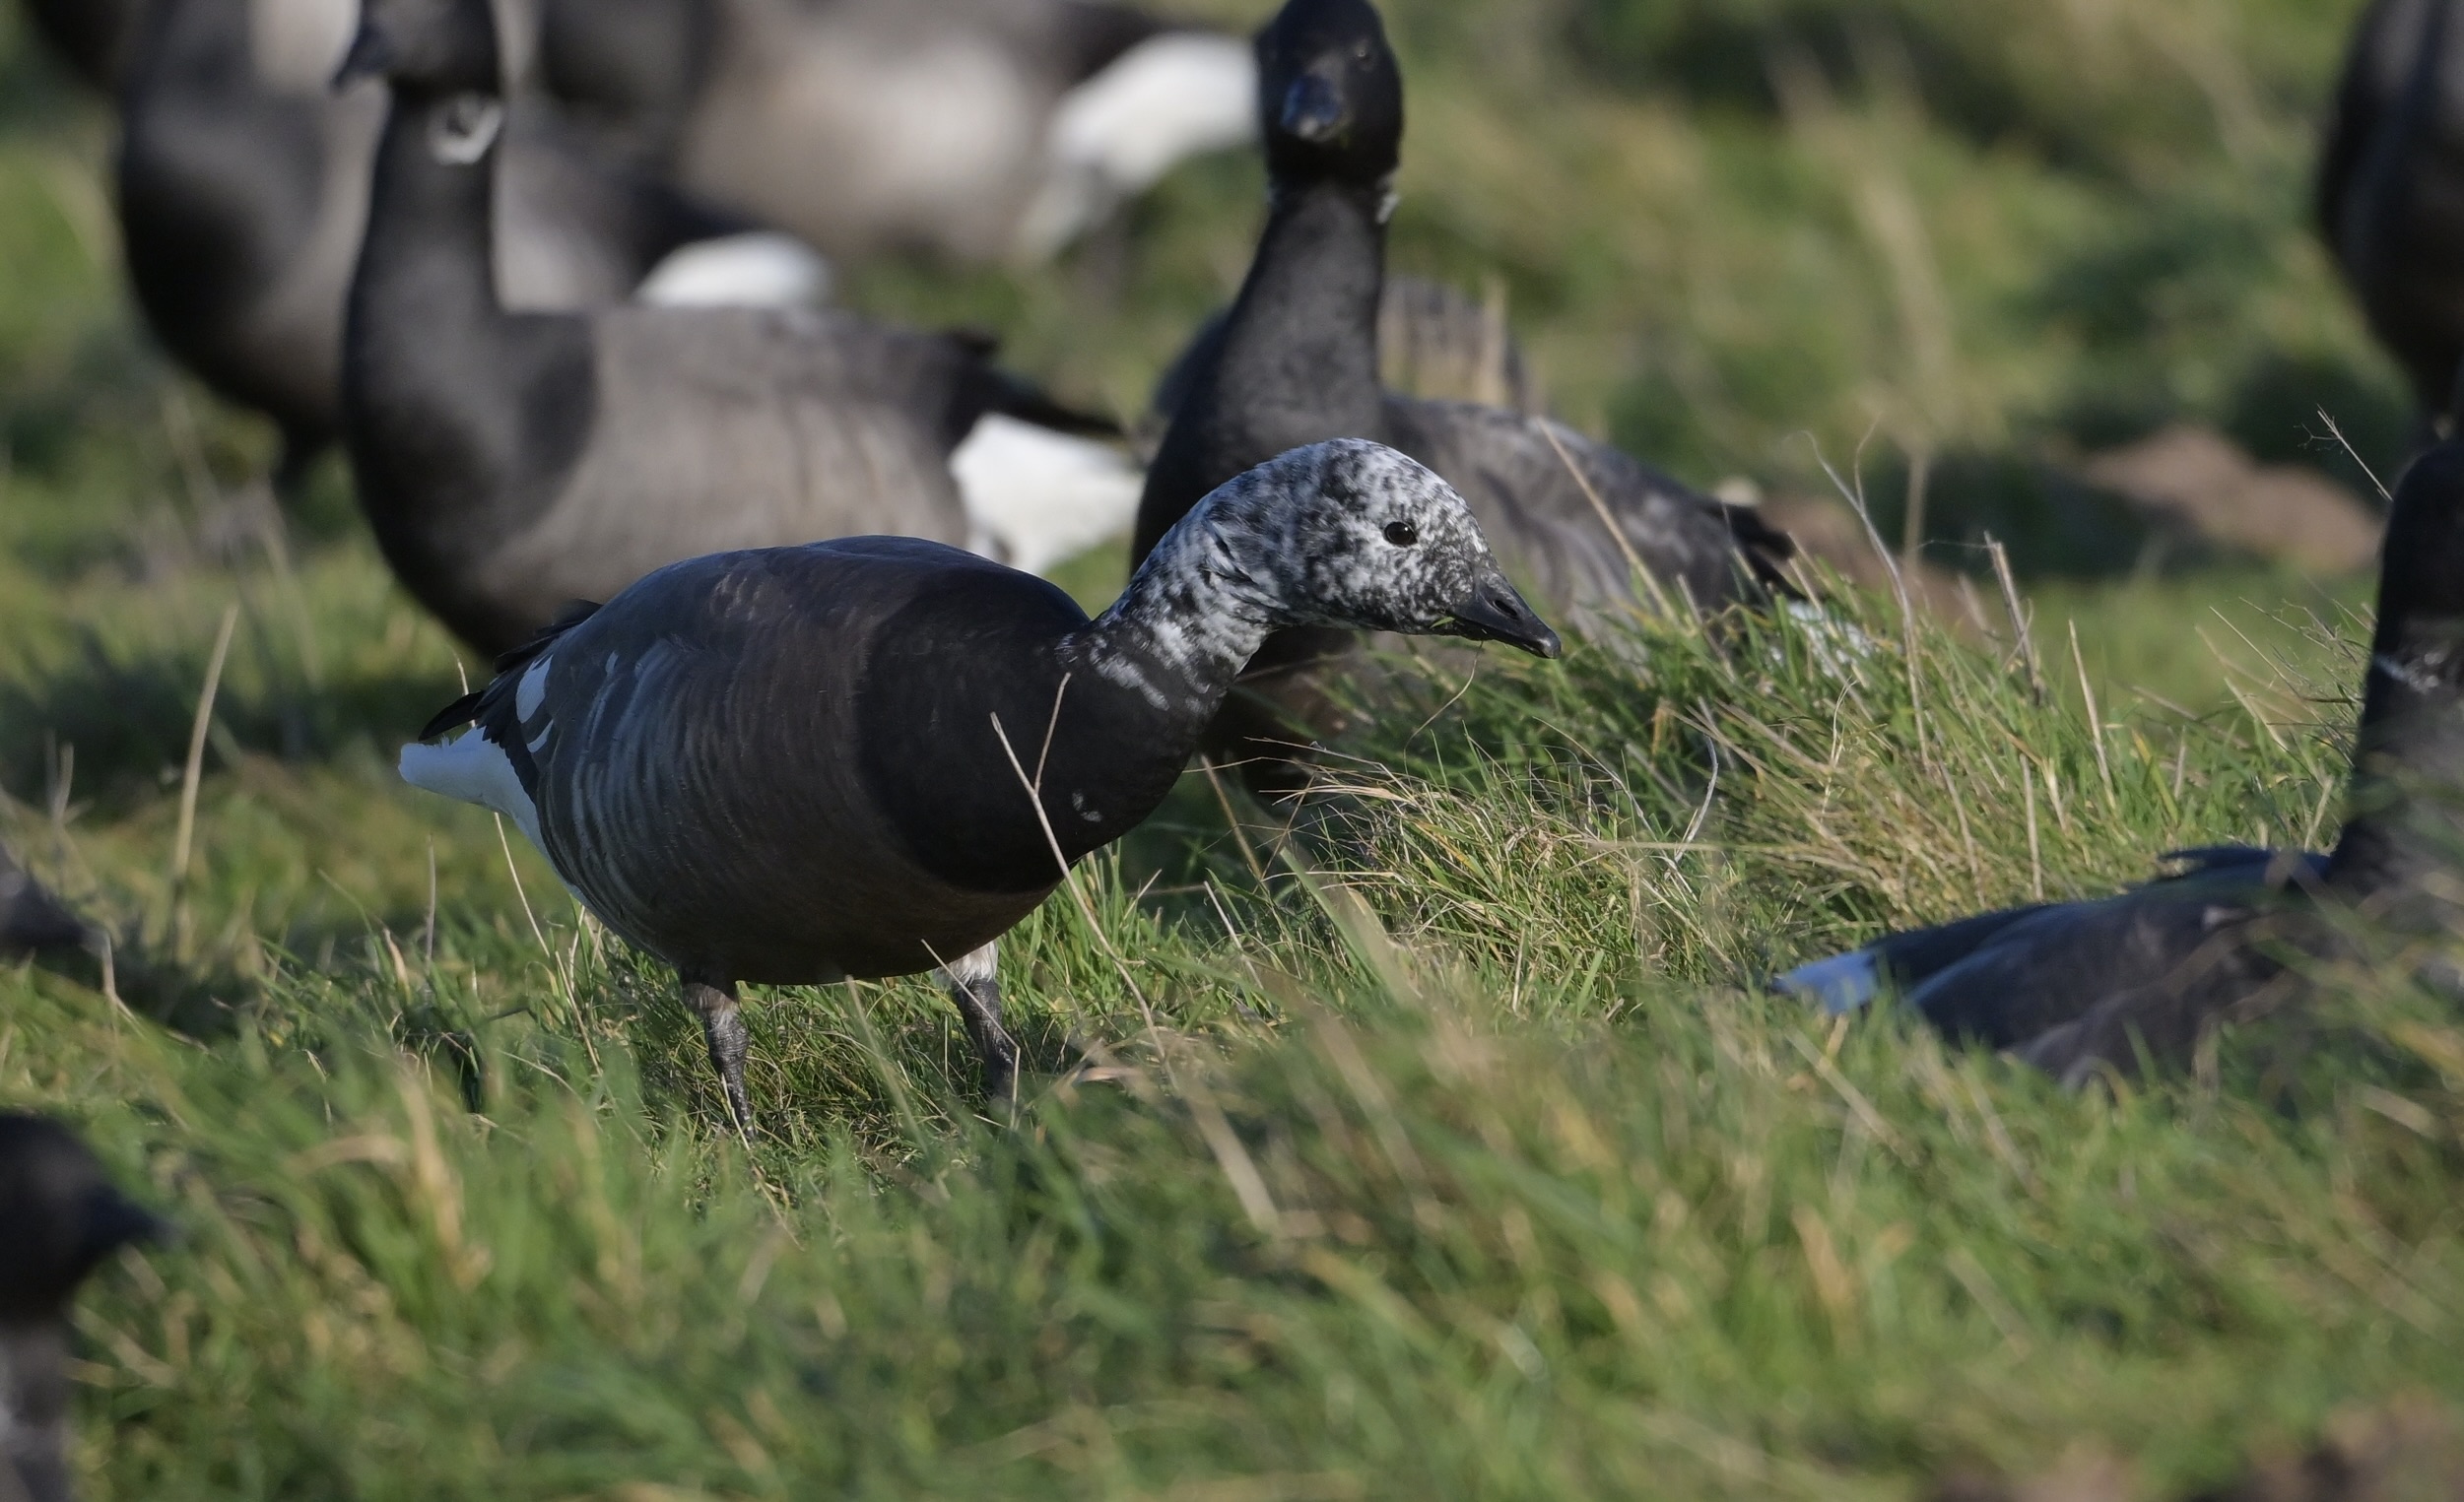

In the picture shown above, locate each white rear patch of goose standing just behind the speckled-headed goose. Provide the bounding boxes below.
[949,414,1146,574]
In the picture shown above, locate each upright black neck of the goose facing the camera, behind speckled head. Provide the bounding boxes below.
[1131,180,1387,559]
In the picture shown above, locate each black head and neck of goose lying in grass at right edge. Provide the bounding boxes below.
[2328,441,2464,914]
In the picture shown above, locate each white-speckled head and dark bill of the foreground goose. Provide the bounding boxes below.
[1192,438,1563,658]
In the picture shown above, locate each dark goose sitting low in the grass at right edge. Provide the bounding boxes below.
[1774,430,2464,1083]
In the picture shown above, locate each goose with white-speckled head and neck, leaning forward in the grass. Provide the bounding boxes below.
[402,441,1558,1123]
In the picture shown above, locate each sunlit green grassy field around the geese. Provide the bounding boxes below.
[0,0,2464,1502]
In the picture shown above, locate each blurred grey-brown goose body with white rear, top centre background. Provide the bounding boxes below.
[540,0,1257,261]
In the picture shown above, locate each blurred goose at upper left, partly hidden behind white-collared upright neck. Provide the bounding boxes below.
[118,0,768,492]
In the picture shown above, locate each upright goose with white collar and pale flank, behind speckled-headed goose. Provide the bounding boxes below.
[343,0,1128,653]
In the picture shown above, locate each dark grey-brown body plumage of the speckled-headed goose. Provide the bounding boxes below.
[407,537,1185,983]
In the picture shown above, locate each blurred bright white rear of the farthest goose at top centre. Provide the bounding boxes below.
[1018,33,1257,261]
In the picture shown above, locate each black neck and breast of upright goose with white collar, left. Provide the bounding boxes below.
[343,87,594,573]
